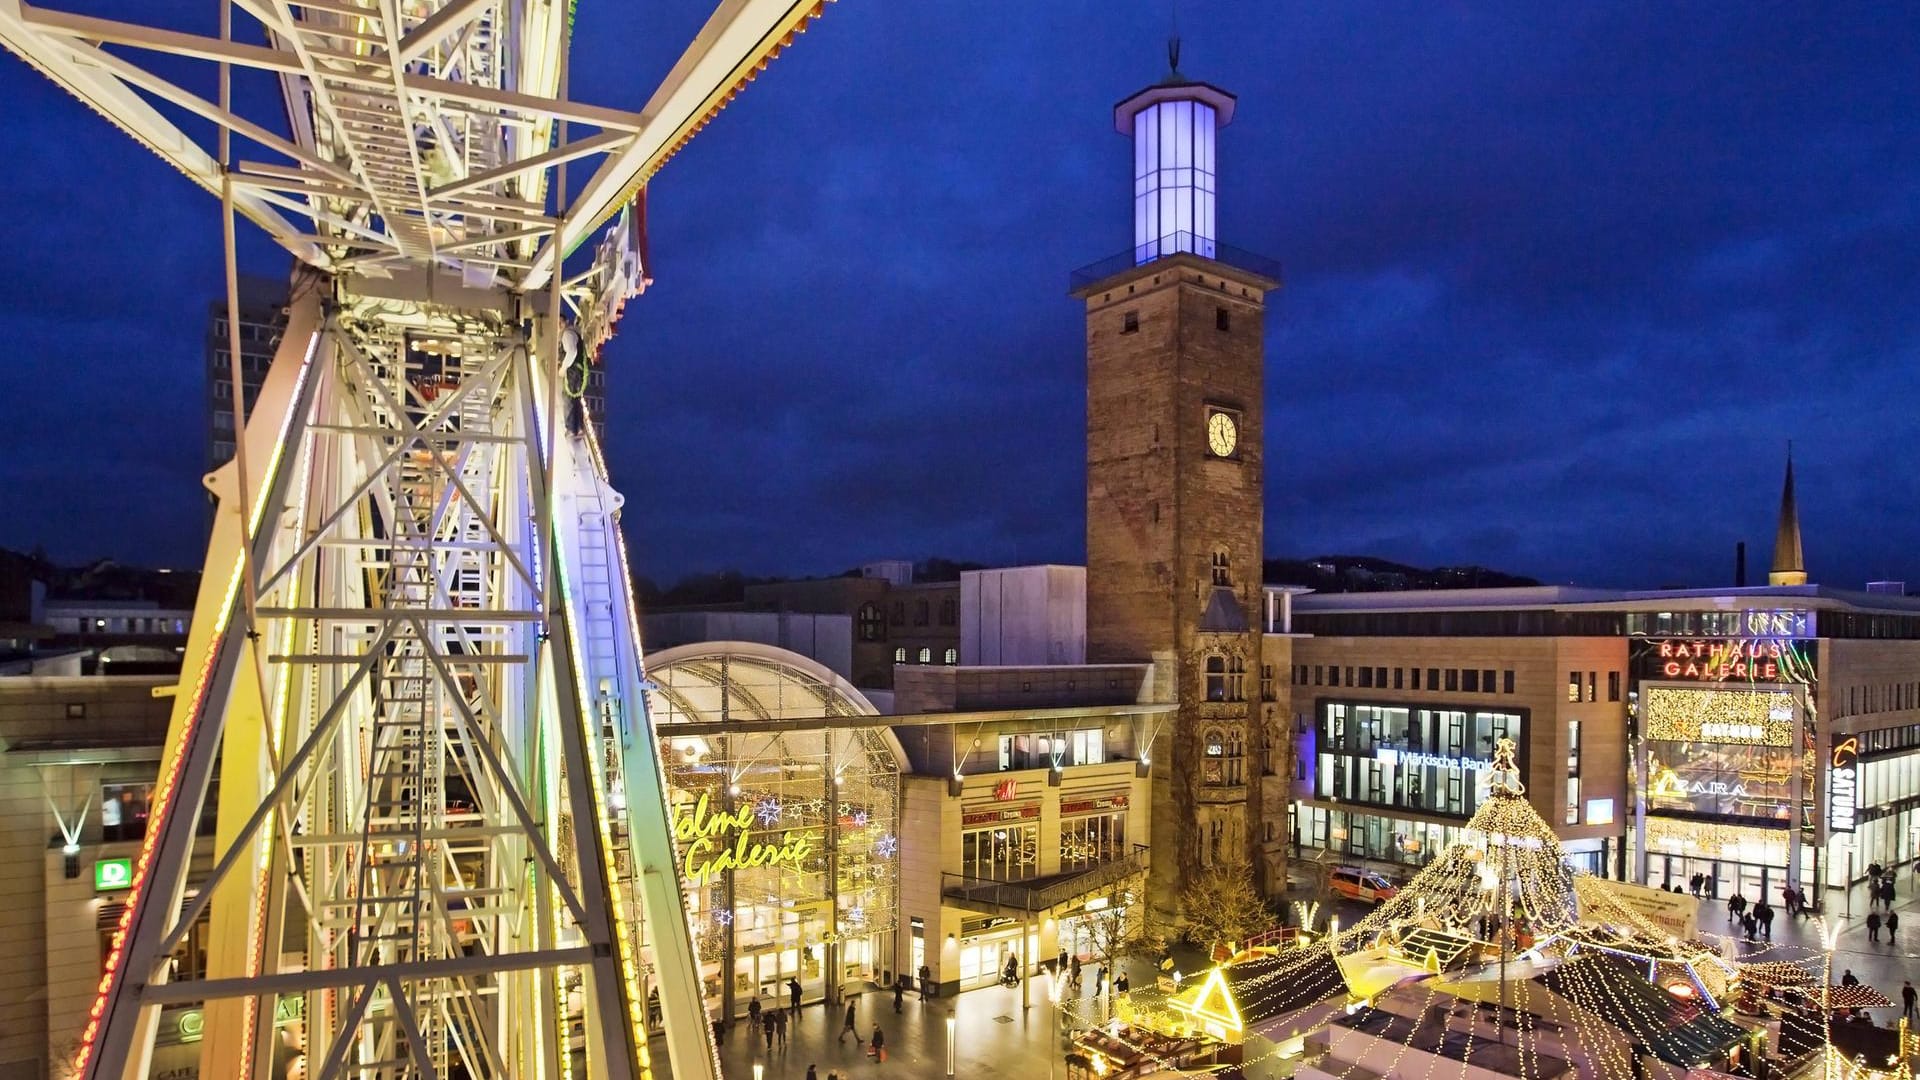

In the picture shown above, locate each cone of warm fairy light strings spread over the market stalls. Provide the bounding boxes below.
[1082,740,1910,1080]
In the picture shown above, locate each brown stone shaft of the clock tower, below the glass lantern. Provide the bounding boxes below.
[1075,254,1275,913]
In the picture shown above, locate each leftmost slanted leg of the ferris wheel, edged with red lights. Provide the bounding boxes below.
[82,296,321,1078]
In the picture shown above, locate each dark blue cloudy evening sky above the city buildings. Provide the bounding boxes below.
[0,0,1920,586]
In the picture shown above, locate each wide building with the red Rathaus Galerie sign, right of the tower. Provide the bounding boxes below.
[1292,584,1920,897]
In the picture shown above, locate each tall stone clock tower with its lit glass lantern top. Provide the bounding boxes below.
[1073,54,1286,915]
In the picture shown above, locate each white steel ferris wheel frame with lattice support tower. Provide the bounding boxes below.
[0,0,840,1080]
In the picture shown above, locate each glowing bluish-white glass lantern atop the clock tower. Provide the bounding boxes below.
[1114,38,1235,263]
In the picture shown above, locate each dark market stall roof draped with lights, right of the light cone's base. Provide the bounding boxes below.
[1536,953,1751,1068]
